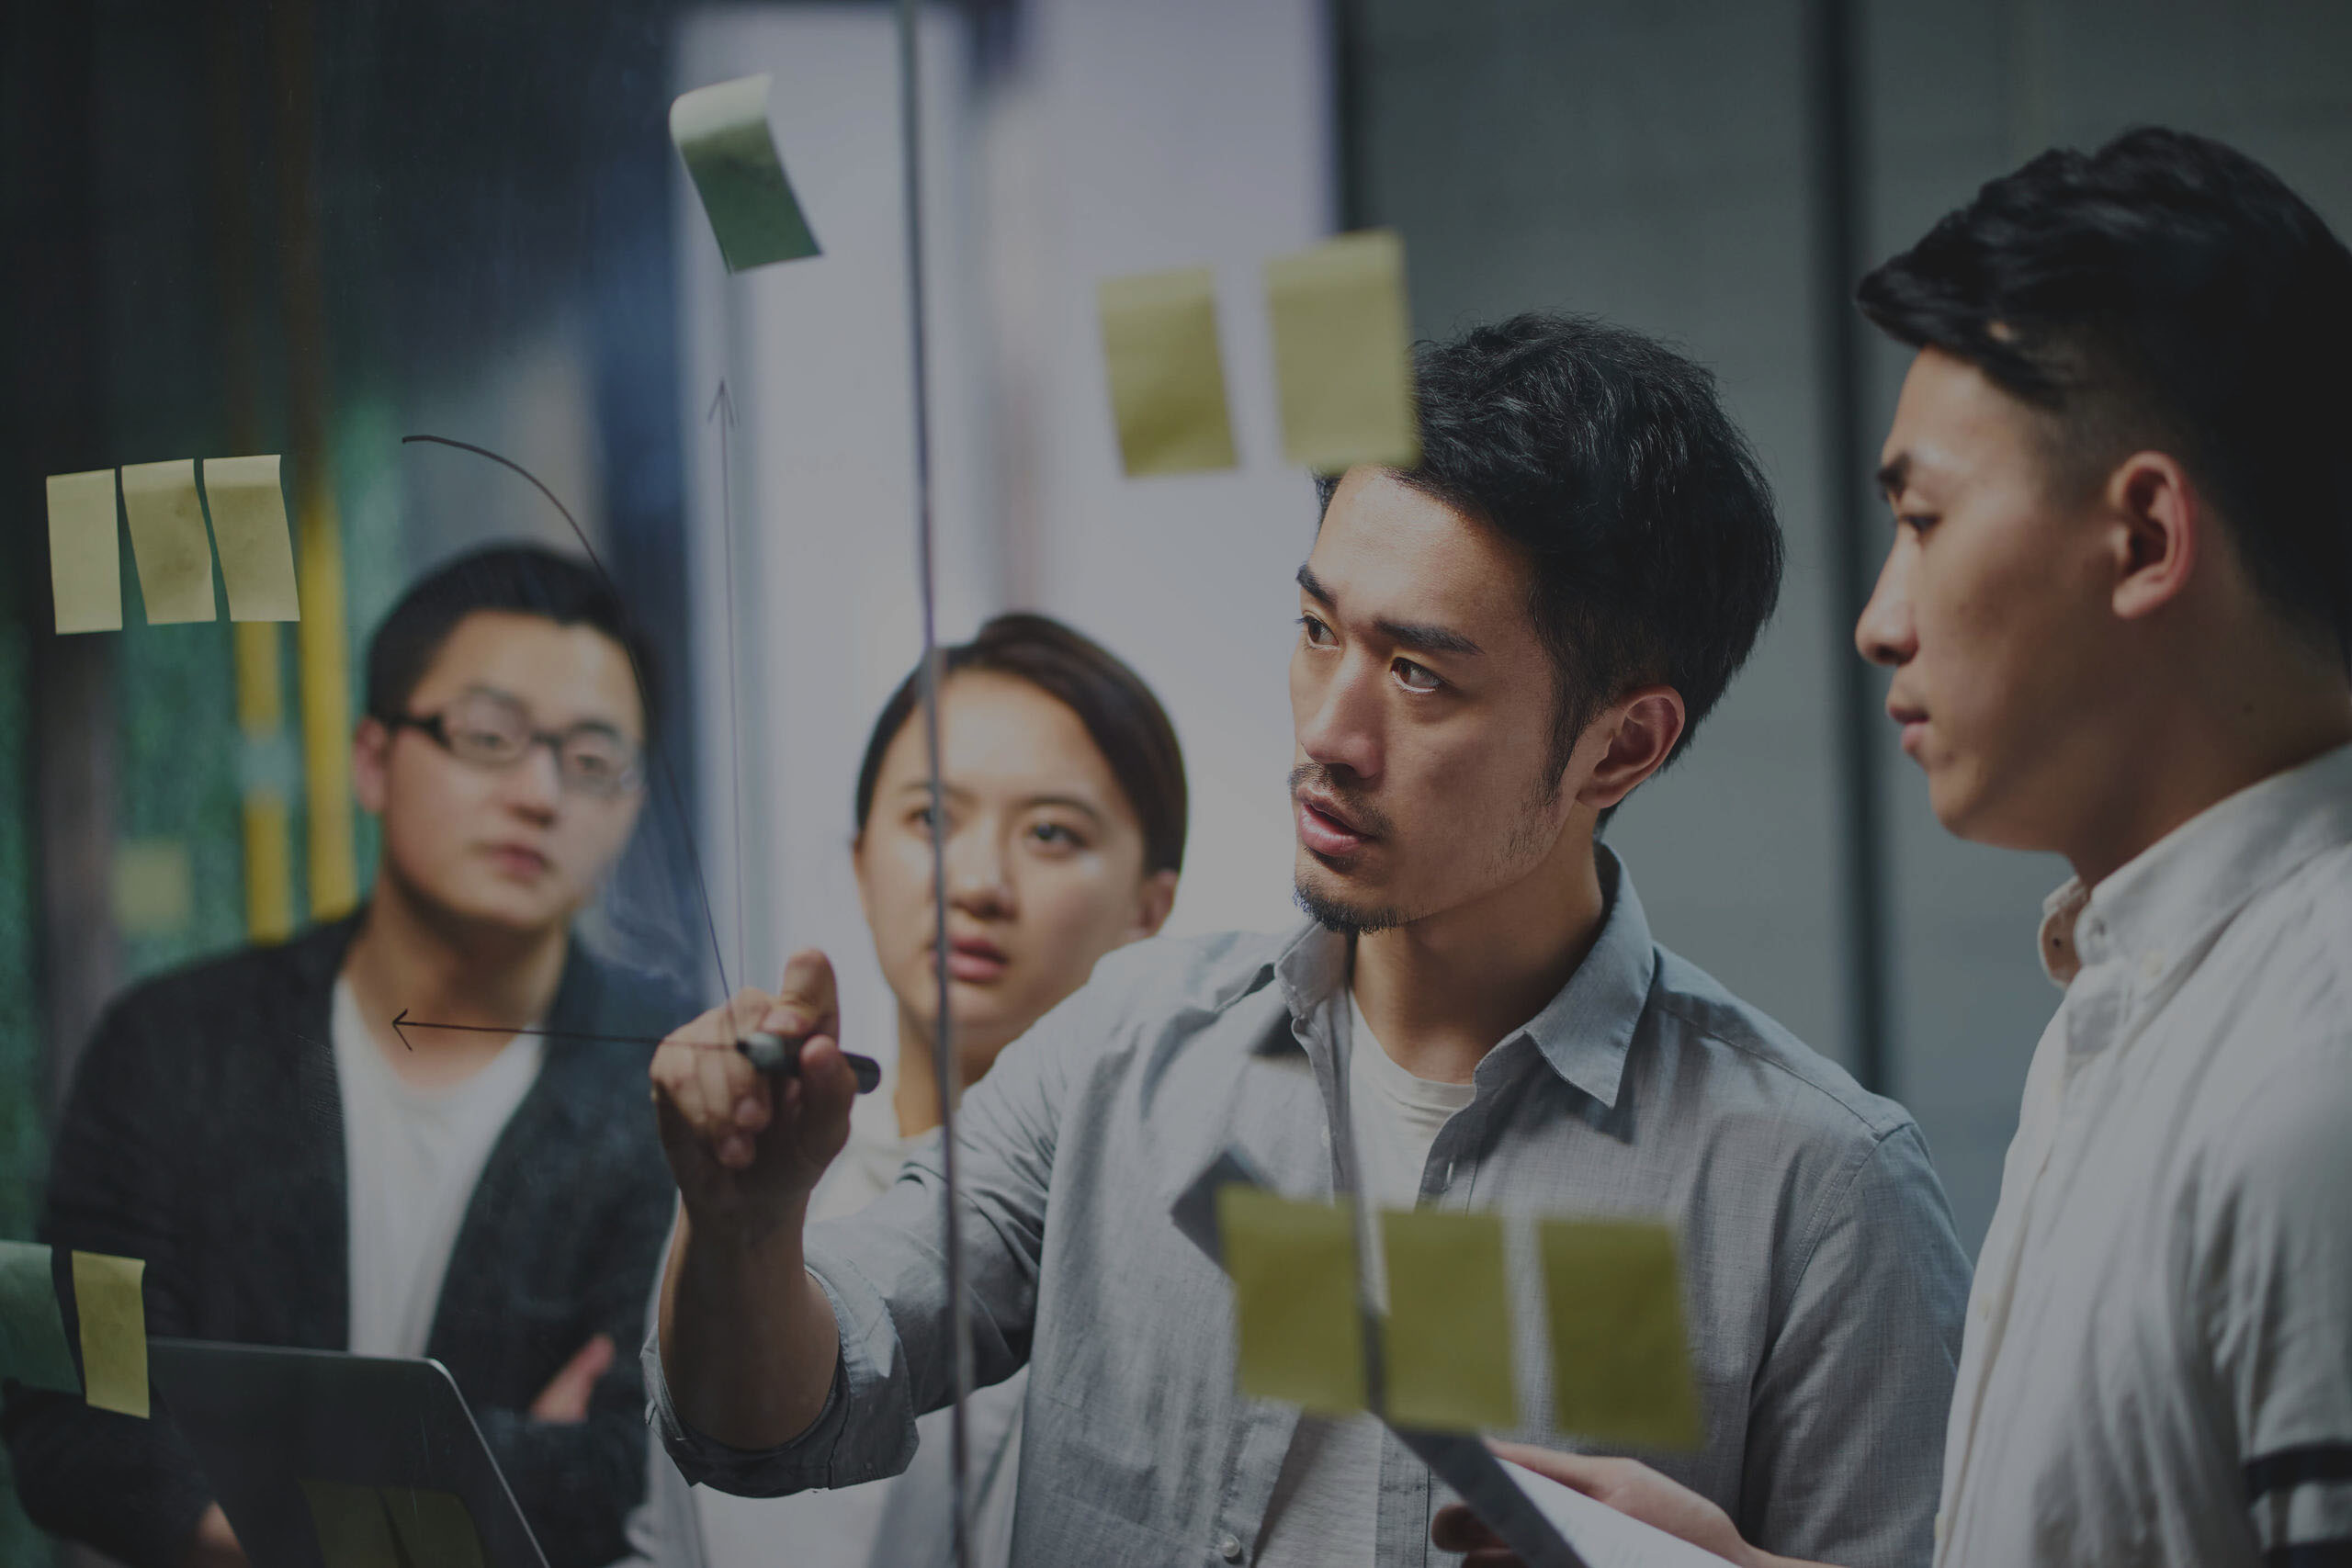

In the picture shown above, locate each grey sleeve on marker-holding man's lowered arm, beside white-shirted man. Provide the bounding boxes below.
[1738,1122,1969,1568]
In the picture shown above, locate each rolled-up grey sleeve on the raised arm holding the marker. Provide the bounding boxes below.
[647,968,1077,1497]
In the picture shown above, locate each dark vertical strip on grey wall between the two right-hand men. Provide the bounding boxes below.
[1806,0,1891,1090]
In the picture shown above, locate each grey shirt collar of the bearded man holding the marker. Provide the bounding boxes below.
[1275,844,1658,1107]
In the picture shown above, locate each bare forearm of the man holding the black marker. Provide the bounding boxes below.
[661,1211,840,1448]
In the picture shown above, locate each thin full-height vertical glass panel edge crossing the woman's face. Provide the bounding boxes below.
[899,0,971,1568]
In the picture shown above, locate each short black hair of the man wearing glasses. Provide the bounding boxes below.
[367,546,659,743]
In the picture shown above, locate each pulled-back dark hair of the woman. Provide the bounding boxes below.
[856,611,1188,877]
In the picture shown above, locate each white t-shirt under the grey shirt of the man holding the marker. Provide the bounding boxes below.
[1259,995,1477,1568]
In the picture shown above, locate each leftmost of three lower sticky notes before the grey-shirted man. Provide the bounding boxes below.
[1216,1182,1364,1416]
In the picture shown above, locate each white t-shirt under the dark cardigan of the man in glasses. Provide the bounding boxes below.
[327,978,541,1357]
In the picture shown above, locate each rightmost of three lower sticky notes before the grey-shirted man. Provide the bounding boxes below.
[1536,1220,1705,1450]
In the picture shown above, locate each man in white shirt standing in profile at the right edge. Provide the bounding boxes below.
[1437,130,2352,1568]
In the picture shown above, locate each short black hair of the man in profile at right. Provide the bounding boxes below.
[1856,130,2352,663]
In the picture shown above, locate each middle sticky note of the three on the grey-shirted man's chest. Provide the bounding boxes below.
[1381,1208,1520,1432]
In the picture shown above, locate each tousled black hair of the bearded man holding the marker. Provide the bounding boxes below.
[1319,312,1782,790]
